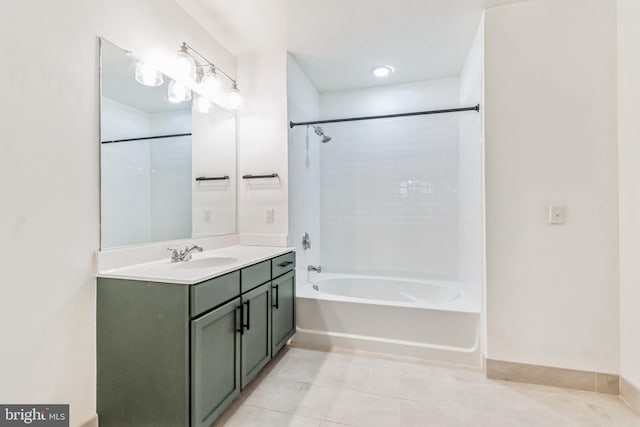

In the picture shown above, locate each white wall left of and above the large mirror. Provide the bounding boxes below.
[0,0,235,426]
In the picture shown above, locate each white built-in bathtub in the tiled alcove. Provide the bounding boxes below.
[295,272,481,366]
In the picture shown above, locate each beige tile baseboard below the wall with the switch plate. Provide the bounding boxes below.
[486,359,620,396]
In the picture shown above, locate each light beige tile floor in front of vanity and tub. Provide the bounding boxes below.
[214,348,640,427]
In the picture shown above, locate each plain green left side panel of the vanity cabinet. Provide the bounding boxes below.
[96,278,190,427]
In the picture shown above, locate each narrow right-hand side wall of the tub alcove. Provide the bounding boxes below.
[458,18,484,303]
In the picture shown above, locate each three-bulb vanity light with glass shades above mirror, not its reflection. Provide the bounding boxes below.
[176,42,244,110]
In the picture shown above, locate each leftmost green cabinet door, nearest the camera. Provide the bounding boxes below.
[191,298,240,427]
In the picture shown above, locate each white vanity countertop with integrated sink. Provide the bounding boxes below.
[97,245,295,285]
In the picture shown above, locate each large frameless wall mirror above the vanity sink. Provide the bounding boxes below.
[100,39,236,249]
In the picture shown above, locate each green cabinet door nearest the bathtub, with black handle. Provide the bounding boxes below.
[271,271,296,356]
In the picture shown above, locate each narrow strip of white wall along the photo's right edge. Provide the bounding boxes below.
[618,0,640,389]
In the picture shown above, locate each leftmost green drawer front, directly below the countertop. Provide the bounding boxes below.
[190,271,240,317]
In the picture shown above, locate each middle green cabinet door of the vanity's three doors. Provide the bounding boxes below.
[242,282,271,388]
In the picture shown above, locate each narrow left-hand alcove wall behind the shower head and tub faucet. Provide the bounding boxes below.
[287,55,322,280]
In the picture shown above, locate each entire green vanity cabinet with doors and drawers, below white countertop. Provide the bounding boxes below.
[96,252,295,427]
